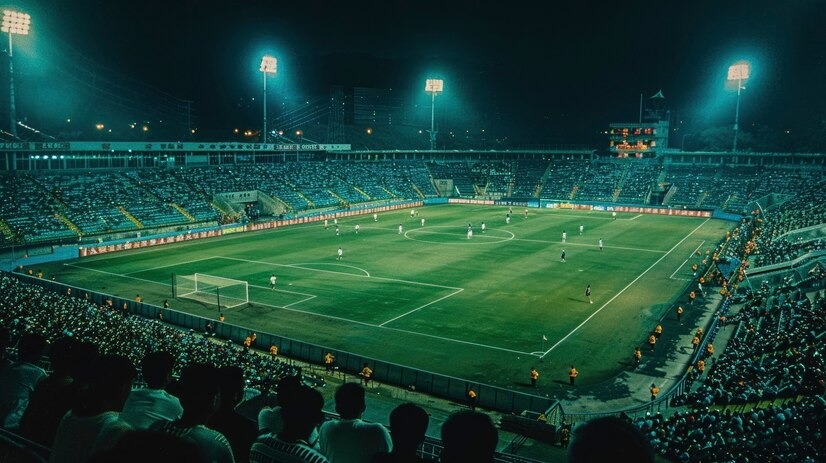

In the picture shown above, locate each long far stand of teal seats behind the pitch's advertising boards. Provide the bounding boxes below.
[0,158,823,247]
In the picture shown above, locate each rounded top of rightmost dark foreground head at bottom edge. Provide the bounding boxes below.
[568,416,654,463]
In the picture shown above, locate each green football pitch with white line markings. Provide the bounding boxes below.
[43,205,731,388]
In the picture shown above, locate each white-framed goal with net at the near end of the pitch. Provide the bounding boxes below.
[173,273,250,309]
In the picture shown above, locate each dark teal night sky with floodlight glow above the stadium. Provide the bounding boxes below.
[8,0,826,143]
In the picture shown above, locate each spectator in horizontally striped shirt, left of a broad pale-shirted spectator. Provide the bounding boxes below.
[250,385,328,463]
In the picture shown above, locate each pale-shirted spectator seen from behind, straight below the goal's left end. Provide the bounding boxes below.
[120,352,184,429]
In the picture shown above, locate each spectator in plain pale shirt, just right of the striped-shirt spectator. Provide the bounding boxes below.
[318,383,392,463]
